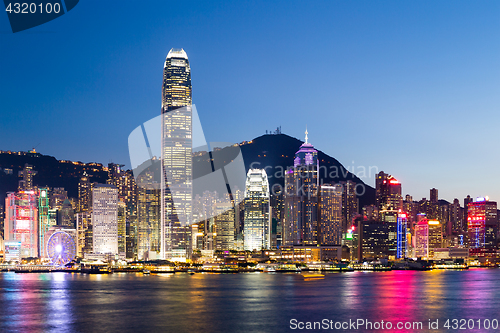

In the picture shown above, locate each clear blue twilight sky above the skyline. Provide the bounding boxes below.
[0,0,500,201]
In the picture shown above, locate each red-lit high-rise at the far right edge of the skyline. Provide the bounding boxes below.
[467,197,498,249]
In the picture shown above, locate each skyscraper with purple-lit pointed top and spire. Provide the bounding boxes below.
[283,131,319,246]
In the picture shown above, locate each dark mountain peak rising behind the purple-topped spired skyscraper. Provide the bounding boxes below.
[240,134,375,208]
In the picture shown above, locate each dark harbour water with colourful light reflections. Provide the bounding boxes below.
[0,269,500,332]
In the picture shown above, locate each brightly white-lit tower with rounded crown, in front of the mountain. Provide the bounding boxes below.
[243,169,271,251]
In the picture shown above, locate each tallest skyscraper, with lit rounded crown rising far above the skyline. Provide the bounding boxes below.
[161,49,193,259]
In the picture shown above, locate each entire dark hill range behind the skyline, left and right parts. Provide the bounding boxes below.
[0,134,375,207]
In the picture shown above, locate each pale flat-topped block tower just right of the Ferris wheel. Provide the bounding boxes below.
[92,184,118,254]
